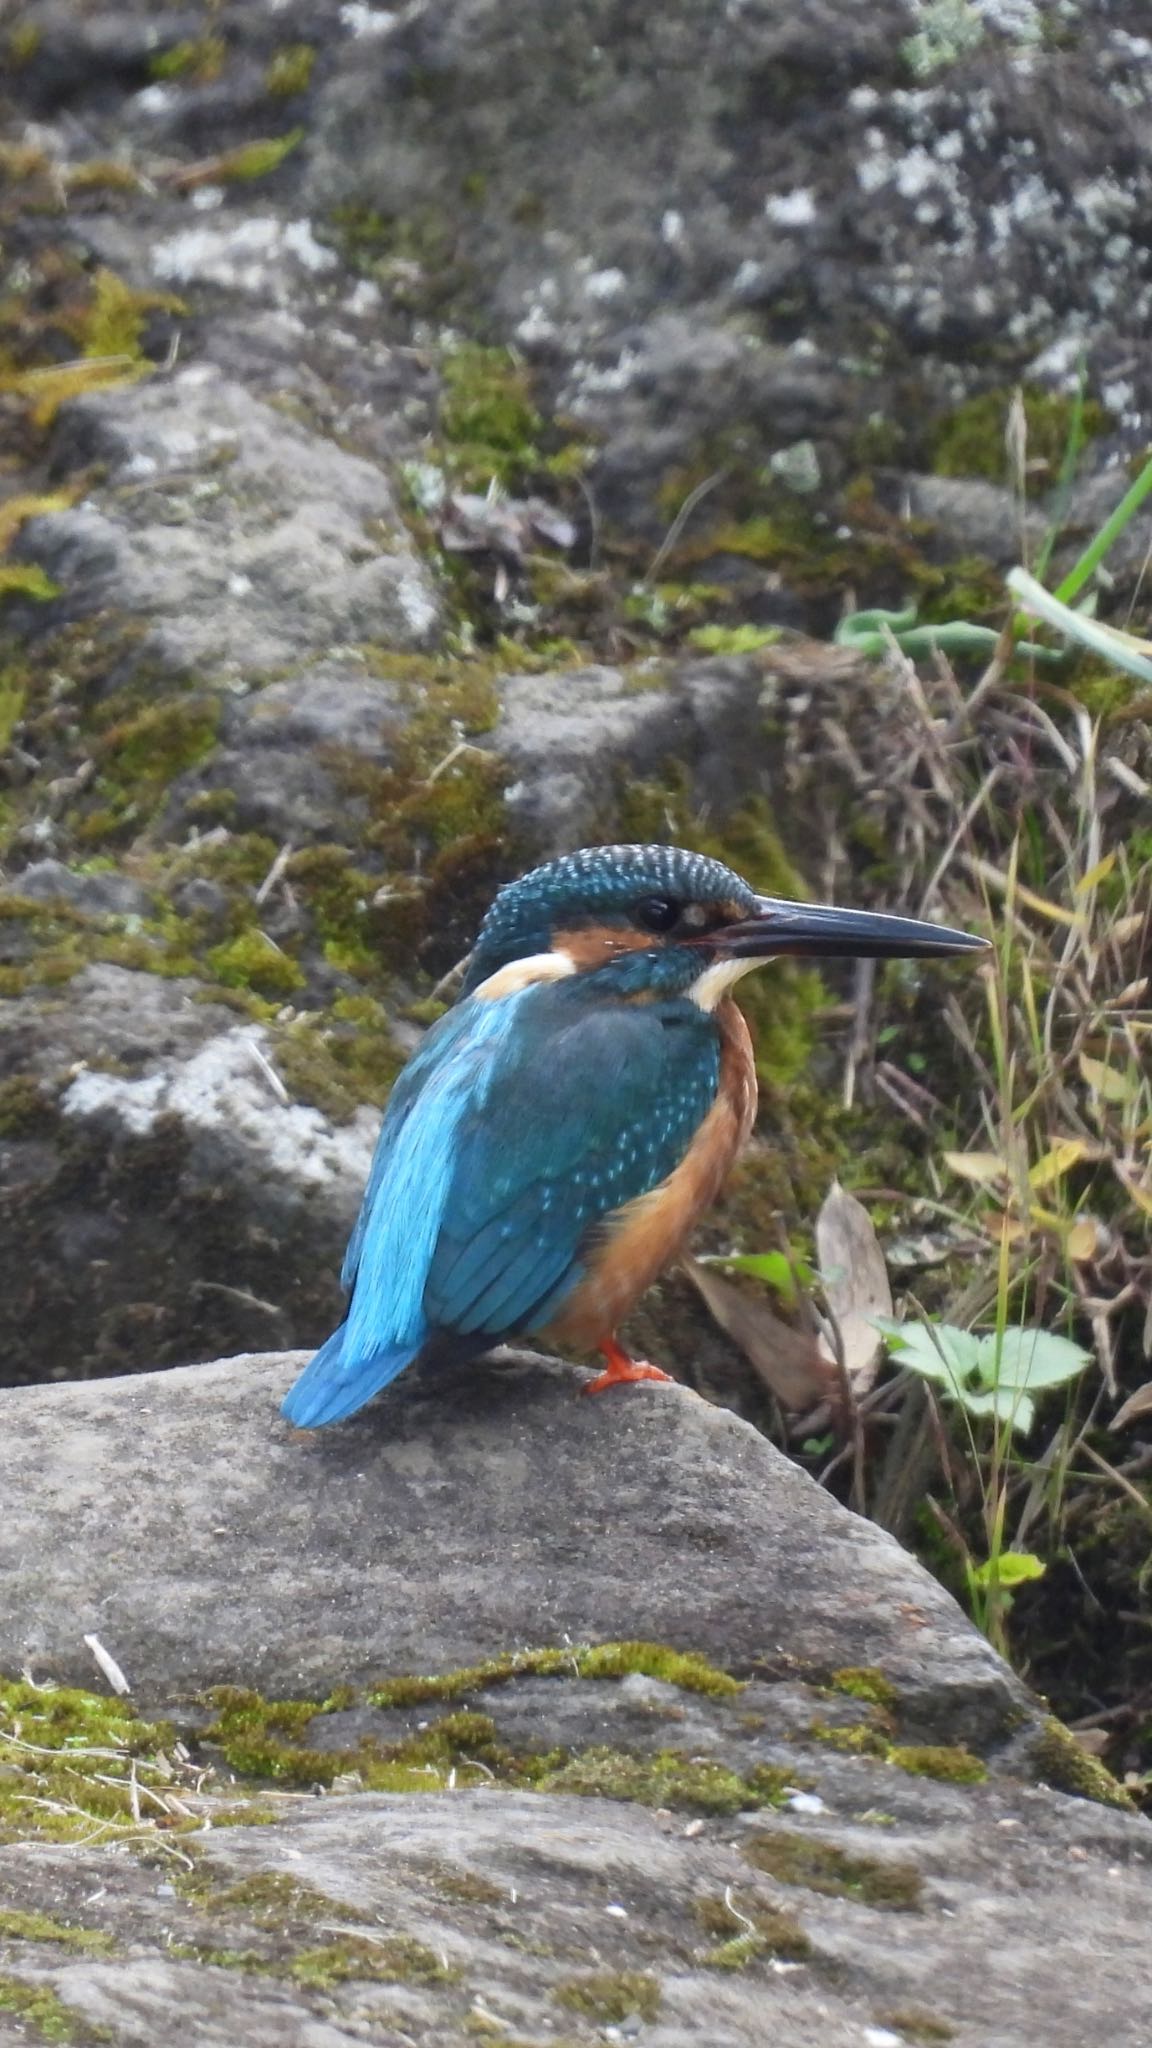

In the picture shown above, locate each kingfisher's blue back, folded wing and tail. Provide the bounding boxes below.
[285,983,719,1427]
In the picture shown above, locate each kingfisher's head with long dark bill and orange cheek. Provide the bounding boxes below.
[461,846,984,1010]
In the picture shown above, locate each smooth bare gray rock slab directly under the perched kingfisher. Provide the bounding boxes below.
[0,1354,1027,1745]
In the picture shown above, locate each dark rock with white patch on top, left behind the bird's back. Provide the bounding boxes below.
[0,965,379,1380]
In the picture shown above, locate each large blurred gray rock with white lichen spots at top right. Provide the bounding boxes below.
[310,0,1152,520]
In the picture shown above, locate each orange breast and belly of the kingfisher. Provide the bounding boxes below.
[547,999,756,1352]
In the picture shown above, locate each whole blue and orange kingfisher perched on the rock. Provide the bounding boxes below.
[283,844,986,1430]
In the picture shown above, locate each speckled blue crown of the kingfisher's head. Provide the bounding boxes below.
[463,846,756,993]
